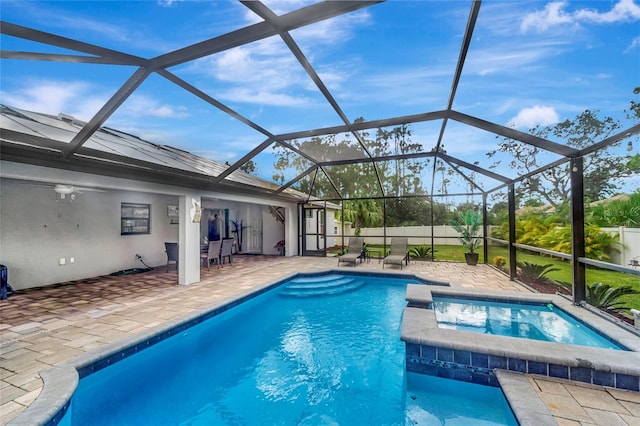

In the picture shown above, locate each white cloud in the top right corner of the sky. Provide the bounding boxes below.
[520,0,640,32]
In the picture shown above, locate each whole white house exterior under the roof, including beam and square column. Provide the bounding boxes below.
[0,161,297,289]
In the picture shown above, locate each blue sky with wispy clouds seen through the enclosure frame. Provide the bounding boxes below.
[0,0,640,191]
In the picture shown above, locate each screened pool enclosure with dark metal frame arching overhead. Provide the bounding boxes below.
[1,0,640,302]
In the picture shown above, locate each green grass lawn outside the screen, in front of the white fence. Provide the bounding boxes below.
[334,245,640,310]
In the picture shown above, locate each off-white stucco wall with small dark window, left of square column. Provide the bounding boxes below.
[0,179,179,289]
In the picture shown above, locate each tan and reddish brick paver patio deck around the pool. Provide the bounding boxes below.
[0,256,640,425]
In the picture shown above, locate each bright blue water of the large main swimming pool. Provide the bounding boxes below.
[62,274,517,425]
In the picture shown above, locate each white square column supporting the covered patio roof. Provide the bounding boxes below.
[178,194,202,285]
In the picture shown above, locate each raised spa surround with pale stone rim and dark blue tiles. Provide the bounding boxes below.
[401,284,640,391]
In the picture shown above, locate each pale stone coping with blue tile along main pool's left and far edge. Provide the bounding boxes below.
[8,268,440,426]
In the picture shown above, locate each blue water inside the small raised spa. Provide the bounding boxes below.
[433,297,626,350]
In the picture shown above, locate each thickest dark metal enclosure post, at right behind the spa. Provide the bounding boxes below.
[570,157,587,305]
